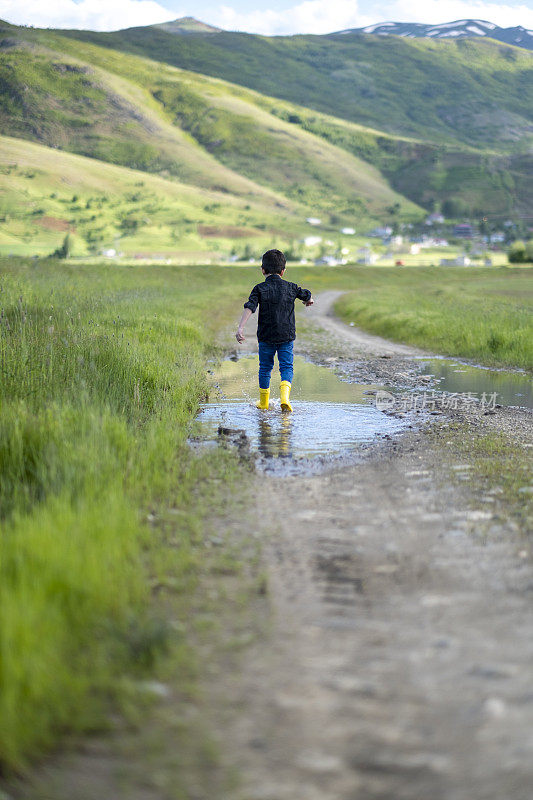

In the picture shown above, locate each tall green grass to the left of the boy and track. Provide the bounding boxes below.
[0,261,247,768]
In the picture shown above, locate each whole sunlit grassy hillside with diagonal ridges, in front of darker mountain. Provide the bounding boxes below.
[0,20,420,239]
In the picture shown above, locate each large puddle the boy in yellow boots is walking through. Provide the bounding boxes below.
[199,356,406,469]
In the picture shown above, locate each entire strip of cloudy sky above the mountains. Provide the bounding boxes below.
[0,0,533,35]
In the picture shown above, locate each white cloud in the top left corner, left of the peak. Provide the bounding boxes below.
[0,0,175,31]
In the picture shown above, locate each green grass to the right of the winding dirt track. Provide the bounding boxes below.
[336,267,533,370]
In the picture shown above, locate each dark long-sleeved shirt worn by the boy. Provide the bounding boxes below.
[244,274,311,344]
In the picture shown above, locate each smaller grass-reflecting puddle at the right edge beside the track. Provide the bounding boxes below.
[416,356,533,409]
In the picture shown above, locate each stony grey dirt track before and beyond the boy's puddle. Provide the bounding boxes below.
[216,293,533,800]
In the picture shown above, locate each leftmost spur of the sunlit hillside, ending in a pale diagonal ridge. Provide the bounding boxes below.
[0,28,286,201]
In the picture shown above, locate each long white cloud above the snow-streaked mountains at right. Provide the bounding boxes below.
[205,0,533,36]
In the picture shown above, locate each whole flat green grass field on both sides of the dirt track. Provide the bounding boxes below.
[0,259,533,769]
